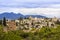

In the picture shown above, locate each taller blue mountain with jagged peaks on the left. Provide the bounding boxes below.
[0,12,23,19]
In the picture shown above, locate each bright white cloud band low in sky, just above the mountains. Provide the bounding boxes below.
[0,8,60,17]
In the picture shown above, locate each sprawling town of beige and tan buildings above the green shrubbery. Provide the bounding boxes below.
[2,16,60,31]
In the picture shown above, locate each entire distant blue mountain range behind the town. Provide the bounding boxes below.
[0,12,46,19]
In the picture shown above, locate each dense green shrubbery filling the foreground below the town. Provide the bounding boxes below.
[0,26,60,40]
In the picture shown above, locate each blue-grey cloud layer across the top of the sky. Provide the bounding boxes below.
[0,0,60,8]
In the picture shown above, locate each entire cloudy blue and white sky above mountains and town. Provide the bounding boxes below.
[0,0,60,17]
